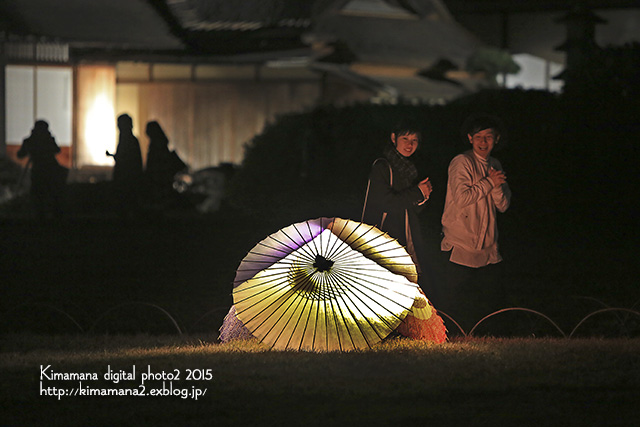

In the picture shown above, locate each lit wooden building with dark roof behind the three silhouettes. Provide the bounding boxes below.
[0,0,636,180]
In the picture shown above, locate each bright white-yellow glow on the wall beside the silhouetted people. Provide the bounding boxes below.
[84,93,116,166]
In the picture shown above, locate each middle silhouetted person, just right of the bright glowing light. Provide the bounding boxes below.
[107,114,142,215]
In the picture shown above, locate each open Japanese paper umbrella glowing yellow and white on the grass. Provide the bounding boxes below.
[233,218,420,351]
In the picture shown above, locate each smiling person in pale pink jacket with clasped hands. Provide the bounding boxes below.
[441,115,511,332]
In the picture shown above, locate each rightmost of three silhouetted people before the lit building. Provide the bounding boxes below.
[145,121,186,204]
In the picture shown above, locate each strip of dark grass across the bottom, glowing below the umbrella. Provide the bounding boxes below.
[0,334,640,426]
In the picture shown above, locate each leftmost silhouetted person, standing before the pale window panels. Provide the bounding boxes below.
[18,120,68,217]
